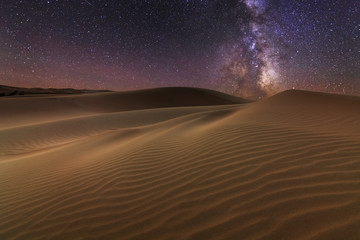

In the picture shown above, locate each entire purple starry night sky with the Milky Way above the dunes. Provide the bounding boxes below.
[0,0,360,99]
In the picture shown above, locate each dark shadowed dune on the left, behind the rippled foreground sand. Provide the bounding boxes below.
[0,87,249,128]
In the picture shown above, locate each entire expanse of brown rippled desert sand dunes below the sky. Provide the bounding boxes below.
[0,88,360,240]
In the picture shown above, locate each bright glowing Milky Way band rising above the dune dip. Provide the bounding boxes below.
[214,0,284,97]
